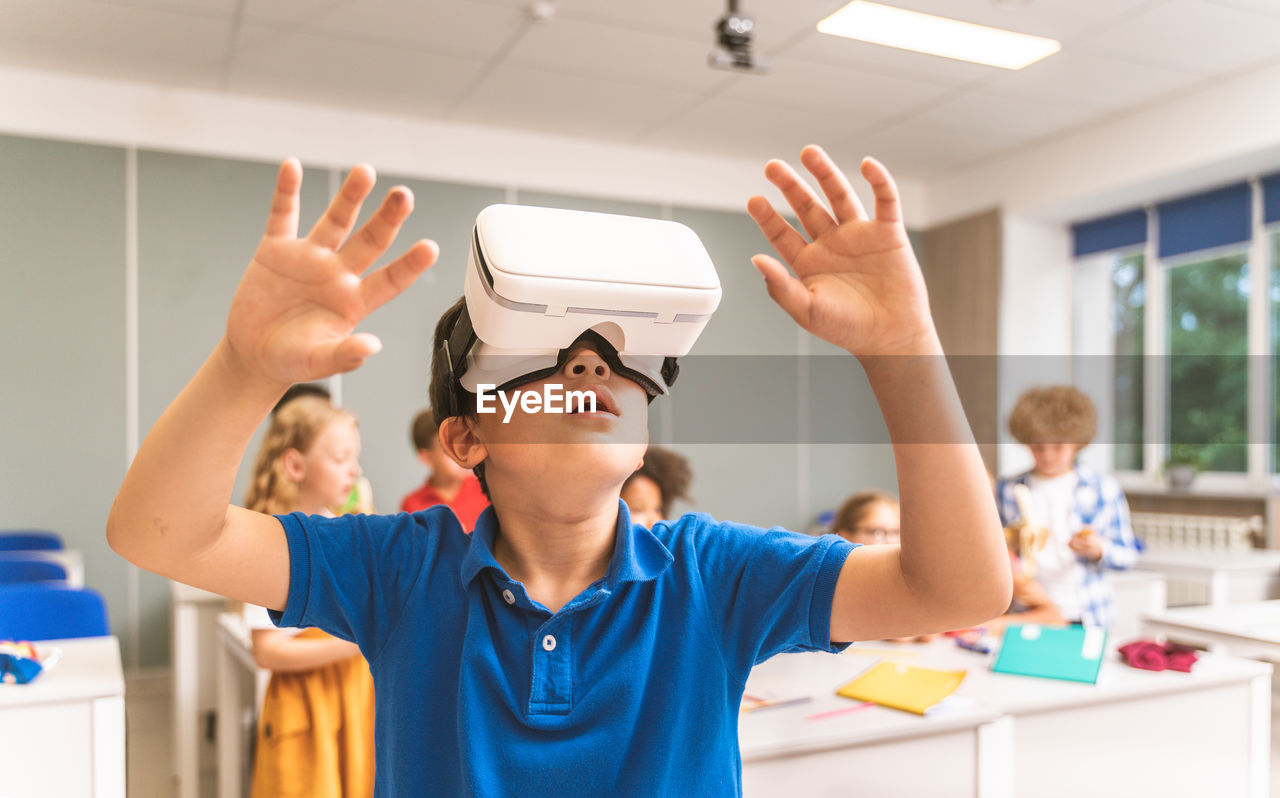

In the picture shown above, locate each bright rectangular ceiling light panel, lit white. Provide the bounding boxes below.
[818,0,1062,69]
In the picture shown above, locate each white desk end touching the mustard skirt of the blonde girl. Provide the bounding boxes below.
[218,612,271,798]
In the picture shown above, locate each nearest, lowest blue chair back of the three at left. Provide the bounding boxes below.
[0,583,111,640]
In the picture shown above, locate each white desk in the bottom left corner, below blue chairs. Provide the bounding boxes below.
[0,637,124,798]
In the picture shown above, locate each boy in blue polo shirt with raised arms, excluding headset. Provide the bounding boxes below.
[108,147,1010,795]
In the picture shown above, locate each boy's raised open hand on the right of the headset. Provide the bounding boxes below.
[746,145,937,356]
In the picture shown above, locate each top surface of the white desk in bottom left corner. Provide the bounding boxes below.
[0,637,124,710]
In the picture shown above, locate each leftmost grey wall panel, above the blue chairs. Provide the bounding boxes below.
[0,136,129,653]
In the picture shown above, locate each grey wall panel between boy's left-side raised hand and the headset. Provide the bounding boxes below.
[342,175,504,512]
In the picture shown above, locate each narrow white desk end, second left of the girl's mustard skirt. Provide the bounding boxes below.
[169,582,227,798]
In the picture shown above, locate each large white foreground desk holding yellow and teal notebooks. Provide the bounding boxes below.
[740,638,1271,798]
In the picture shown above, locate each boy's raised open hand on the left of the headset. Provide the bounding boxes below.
[227,159,438,384]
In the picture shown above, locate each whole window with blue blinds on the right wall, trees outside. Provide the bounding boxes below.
[1073,174,1280,488]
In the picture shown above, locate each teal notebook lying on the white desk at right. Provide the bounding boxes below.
[991,624,1107,684]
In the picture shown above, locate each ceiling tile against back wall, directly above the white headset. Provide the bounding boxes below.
[449,64,698,141]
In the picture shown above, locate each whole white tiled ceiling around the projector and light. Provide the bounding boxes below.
[0,0,1280,179]
